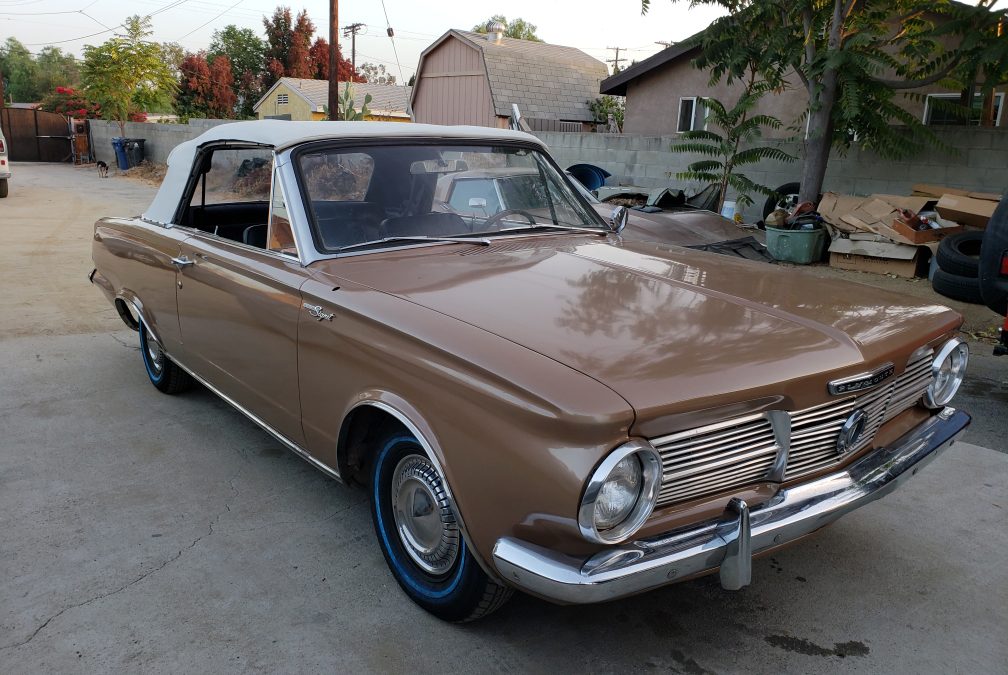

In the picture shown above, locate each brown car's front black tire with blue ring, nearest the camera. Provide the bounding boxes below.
[369,430,512,622]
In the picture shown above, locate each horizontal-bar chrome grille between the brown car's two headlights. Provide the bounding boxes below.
[651,352,932,506]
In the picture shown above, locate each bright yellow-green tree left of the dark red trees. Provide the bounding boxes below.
[82,16,176,135]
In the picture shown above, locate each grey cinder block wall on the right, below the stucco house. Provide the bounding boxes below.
[535,128,1008,221]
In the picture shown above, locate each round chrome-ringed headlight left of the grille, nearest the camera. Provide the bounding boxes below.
[578,440,661,544]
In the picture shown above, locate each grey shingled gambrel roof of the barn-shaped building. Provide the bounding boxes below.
[410,28,609,122]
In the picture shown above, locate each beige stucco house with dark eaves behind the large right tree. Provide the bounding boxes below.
[600,35,1008,137]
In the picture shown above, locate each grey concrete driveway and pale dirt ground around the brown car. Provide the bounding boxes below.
[0,165,1008,673]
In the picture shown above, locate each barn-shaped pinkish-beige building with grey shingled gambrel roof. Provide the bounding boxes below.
[411,29,608,131]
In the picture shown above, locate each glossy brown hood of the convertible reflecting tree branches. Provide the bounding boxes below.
[323,236,961,417]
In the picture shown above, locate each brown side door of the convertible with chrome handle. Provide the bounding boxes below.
[177,151,307,444]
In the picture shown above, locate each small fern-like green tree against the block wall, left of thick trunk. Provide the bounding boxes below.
[671,71,794,213]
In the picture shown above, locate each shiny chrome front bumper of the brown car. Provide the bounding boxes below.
[494,408,970,603]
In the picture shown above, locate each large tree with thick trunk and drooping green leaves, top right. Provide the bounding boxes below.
[641,0,1003,201]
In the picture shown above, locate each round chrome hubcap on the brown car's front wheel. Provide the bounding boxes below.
[392,454,460,575]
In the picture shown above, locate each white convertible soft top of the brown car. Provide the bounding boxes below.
[143,120,545,223]
